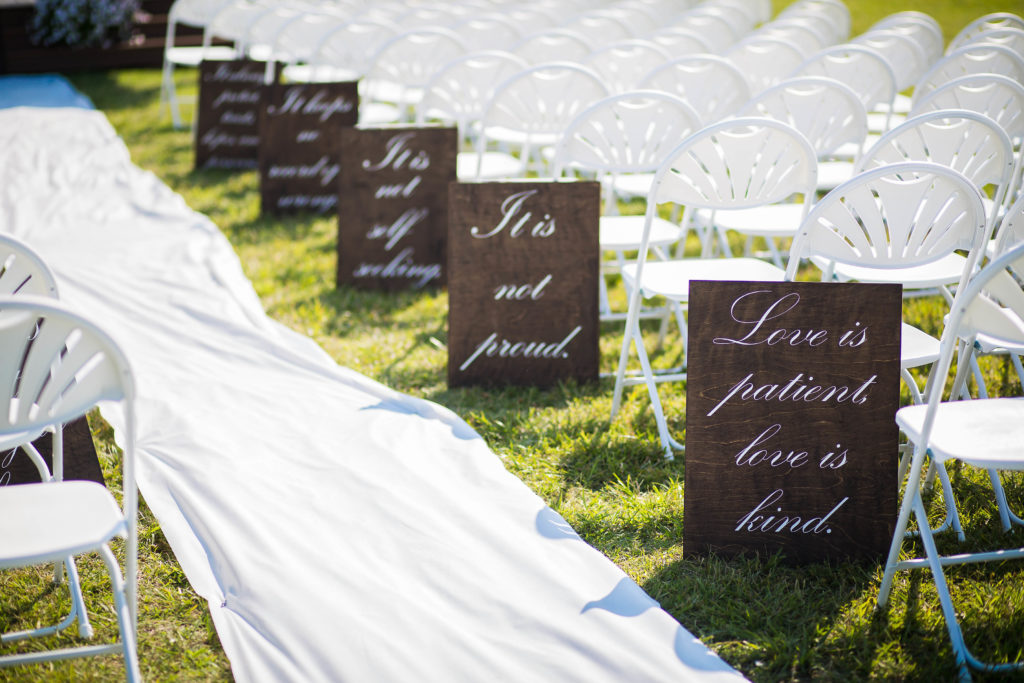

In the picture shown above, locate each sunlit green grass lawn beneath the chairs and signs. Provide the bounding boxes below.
[0,0,1024,681]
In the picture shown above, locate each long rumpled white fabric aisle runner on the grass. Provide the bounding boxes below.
[0,108,739,682]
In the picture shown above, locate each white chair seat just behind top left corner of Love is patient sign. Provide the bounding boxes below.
[623,258,785,301]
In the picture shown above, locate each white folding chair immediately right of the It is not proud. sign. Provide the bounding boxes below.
[553,90,700,321]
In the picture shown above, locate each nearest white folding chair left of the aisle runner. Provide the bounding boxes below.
[0,296,140,681]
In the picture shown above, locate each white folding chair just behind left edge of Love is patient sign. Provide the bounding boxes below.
[611,118,817,458]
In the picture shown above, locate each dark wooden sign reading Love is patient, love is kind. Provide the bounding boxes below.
[683,282,902,562]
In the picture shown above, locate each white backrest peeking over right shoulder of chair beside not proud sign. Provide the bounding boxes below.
[637,54,751,124]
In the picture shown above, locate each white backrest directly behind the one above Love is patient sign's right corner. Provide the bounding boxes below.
[854,110,1017,226]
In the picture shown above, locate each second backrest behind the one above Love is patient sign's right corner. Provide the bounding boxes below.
[909,74,1024,139]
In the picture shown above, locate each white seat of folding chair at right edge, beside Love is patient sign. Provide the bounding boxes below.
[896,398,1024,470]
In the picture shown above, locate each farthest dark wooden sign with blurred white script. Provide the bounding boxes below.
[195,59,266,169]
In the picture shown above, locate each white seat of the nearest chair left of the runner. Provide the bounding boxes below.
[0,481,125,568]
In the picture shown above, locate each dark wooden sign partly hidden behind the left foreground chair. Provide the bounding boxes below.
[0,417,103,486]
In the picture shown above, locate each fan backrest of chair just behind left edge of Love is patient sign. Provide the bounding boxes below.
[647,117,817,211]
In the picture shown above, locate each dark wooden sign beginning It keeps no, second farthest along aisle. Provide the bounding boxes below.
[259,82,359,215]
